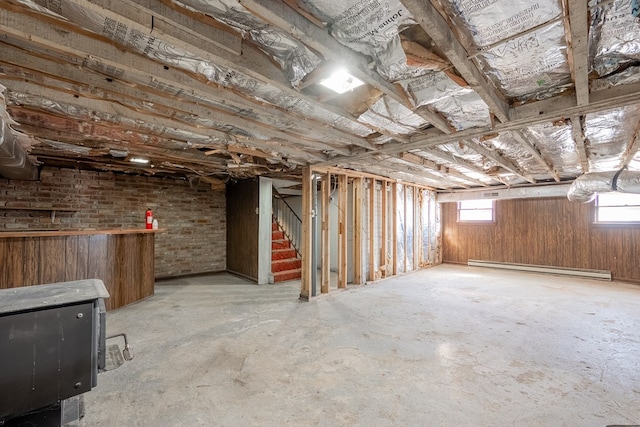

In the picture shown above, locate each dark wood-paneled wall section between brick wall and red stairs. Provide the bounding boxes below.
[227,179,260,280]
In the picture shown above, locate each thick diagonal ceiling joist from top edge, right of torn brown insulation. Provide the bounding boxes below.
[401,0,509,122]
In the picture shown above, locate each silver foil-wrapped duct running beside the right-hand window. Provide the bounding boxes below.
[567,169,640,203]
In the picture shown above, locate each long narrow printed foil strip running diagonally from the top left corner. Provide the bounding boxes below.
[18,0,372,144]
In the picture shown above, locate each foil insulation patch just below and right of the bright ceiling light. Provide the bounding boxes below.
[358,96,429,135]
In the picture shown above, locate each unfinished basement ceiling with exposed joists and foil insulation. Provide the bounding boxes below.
[0,0,640,190]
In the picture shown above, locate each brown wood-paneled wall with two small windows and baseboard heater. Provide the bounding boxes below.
[442,198,640,282]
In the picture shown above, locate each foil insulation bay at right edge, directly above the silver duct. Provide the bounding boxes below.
[584,104,640,172]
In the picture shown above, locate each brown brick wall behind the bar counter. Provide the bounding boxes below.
[0,168,226,277]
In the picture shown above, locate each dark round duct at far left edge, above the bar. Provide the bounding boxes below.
[0,85,38,181]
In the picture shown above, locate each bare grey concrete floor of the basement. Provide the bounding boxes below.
[83,265,640,427]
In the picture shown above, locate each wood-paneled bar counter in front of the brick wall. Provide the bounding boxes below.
[0,229,162,310]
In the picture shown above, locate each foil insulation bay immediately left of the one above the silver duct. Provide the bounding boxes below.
[524,123,582,178]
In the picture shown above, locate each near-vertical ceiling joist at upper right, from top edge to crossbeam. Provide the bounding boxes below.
[564,0,589,106]
